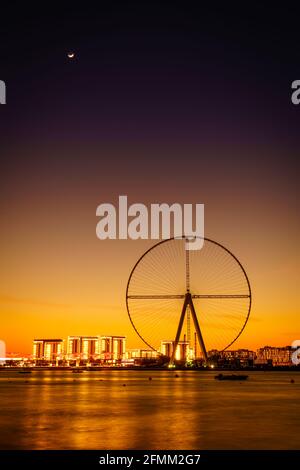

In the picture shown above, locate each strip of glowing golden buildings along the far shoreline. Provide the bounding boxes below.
[0,335,300,370]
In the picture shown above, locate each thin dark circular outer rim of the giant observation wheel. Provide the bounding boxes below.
[126,235,252,352]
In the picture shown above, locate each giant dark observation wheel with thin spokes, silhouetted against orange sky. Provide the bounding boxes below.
[126,237,251,362]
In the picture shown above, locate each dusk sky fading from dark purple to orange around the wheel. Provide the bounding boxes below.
[0,2,300,353]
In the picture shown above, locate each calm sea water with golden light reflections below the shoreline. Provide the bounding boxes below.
[0,370,300,450]
